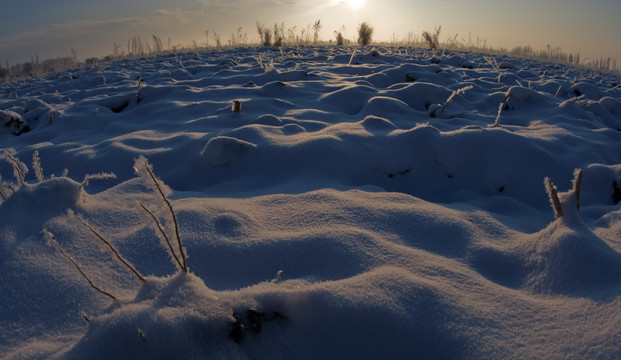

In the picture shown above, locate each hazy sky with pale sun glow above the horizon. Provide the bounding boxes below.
[0,0,621,66]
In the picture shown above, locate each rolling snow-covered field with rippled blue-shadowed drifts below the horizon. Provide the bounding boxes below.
[0,47,621,359]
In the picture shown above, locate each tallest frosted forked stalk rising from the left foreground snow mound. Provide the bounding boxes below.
[134,156,188,273]
